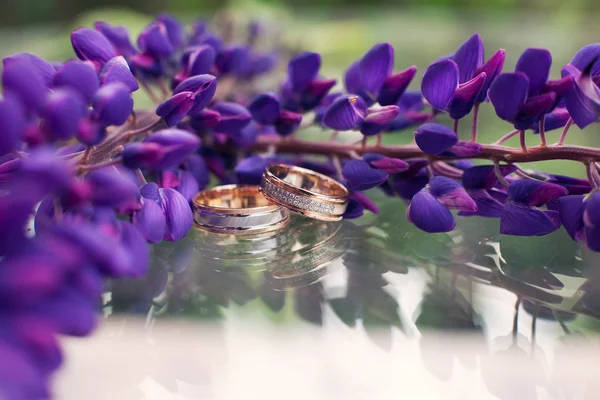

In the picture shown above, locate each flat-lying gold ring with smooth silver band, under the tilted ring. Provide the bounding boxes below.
[194,185,290,235]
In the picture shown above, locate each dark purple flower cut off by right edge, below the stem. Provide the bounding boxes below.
[558,192,600,251]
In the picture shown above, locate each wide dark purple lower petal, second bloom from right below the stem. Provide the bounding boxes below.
[500,205,560,236]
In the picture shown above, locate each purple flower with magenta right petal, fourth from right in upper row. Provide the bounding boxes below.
[344,43,417,106]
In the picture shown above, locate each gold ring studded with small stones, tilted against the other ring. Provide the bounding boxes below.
[260,164,349,221]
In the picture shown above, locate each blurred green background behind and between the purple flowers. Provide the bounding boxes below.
[0,0,600,176]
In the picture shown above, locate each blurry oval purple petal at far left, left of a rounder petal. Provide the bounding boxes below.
[43,88,87,140]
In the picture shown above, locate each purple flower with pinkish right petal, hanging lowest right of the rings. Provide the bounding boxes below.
[406,176,477,233]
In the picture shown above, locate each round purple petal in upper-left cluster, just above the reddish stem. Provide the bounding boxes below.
[92,83,133,126]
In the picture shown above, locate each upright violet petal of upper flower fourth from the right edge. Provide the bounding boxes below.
[359,43,394,100]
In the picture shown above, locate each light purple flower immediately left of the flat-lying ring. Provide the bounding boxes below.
[133,182,194,242]
